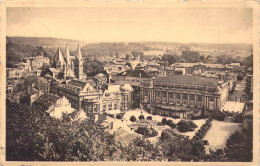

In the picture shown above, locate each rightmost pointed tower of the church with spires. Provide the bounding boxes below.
[74,45,84,80]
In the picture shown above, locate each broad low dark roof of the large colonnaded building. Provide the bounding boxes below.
[155,75,220,85]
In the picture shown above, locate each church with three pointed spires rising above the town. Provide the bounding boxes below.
[42,45,86,80]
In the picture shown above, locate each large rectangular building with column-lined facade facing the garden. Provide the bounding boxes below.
[140,75,229,118]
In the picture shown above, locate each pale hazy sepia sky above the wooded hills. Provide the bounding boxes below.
[6,7,253,44]
